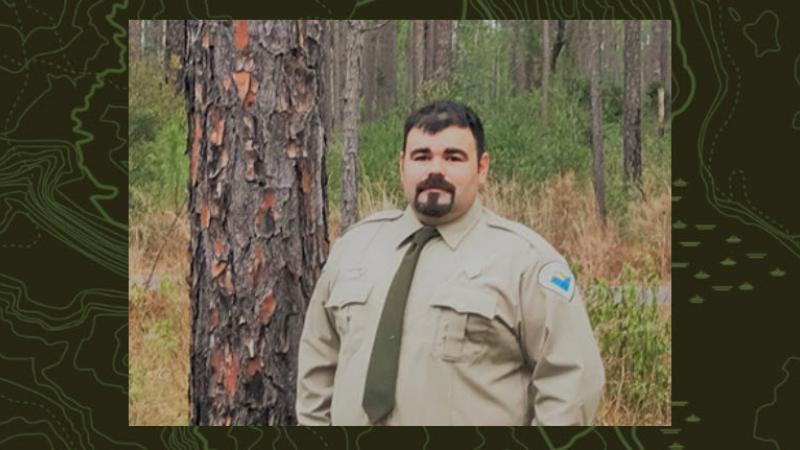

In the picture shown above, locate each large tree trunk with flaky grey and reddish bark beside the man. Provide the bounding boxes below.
[185,20,328,426]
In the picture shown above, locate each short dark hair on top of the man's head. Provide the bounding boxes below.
[403,100,486,160]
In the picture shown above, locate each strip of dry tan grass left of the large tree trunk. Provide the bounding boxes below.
[128,207,190,426]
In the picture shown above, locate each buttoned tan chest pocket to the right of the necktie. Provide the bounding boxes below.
[431,287,501,362]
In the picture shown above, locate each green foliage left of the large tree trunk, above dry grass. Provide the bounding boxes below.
[128,60,189,215]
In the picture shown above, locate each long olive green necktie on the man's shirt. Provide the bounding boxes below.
[361,226,439,423]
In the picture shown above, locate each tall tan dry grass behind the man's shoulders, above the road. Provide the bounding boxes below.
[329,173,672,284]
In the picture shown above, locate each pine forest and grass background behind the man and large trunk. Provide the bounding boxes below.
[128,20,681,425]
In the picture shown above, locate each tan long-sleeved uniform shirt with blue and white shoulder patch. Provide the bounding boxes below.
[297,200,605,425]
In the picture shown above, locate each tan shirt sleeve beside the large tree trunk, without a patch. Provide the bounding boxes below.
[296,244,339,425]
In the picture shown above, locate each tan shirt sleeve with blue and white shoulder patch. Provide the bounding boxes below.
[521,260,605,426]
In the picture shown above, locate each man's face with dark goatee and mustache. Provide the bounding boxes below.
[400,126,489,225]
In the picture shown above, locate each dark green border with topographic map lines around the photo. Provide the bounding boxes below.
[0,0,800,449]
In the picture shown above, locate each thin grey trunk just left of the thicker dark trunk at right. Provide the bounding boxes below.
[588,20,607,227]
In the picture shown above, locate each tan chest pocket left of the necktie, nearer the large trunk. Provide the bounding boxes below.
[325,279,372,353]
